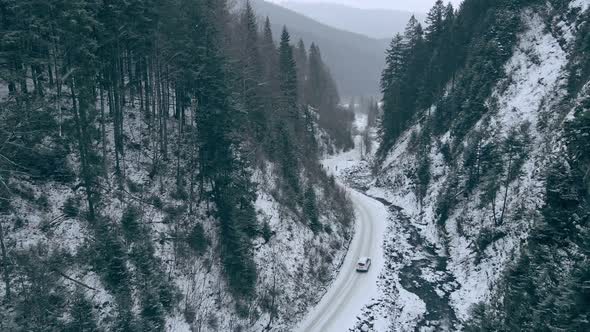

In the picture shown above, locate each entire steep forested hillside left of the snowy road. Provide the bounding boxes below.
[0,0,354,331]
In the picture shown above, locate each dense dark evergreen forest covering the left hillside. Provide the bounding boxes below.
[0,0,353,331]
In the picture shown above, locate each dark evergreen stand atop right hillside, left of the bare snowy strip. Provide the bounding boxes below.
[381,0,531,152]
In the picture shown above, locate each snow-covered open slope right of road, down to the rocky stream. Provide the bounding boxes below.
[348,1,590,331]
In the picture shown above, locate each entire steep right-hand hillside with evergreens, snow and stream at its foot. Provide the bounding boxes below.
[348,0,590,331]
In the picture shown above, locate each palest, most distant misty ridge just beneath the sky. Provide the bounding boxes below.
[281,1,424,39]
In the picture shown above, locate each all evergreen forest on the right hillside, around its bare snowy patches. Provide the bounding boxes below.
[379,0,590,331]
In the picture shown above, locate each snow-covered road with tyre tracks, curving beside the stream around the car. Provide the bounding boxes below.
[297,190,388,332]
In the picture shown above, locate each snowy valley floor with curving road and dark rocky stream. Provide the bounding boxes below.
[298,118,470,331]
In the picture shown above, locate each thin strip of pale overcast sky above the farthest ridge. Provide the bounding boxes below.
[267,0,462,13]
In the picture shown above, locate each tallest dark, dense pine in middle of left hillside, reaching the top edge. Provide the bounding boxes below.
[197,3,256,296]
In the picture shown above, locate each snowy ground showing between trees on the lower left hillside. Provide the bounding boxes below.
[0,92,354,332]
